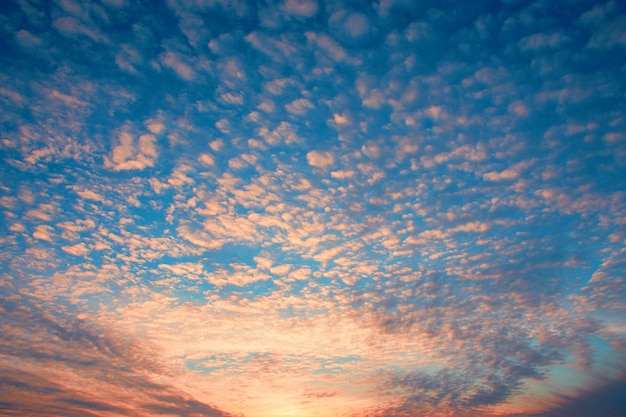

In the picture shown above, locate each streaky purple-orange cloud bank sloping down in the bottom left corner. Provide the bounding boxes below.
[0,297,234,417]
